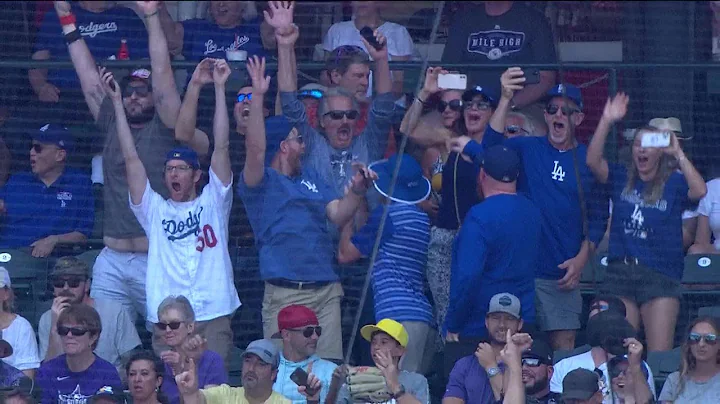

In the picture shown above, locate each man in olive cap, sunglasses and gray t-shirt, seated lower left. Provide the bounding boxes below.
[38,257,141,375]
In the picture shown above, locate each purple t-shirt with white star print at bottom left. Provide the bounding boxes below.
[35,354,122,404]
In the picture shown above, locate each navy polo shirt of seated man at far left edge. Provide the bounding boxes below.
[0,168,95,248]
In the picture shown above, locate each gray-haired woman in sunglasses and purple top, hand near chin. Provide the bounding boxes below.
[155,295,228,403]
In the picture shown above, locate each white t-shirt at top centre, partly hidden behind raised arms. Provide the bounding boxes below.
[323,20,415,97]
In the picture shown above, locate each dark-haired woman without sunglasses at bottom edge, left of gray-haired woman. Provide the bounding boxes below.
[125,351,170,404]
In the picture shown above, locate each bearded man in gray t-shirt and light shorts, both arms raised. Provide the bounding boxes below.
[55,1,207,317]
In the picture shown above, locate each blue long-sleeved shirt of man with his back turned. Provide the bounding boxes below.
[444,194,542,337]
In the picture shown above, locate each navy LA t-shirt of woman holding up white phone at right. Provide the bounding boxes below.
[608,164,689,280]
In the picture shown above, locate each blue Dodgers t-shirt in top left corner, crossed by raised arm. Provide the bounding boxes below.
[33,5,149,89]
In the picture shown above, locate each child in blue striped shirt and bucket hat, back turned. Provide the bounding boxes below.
[338,154,434,373]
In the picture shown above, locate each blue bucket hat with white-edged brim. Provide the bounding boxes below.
[368,154,430,204]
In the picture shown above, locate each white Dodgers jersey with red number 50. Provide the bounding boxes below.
[130,169,240,323]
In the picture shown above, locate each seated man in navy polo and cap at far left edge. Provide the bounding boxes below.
[0,124,95,257]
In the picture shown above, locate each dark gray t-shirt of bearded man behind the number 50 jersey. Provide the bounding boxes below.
[96,97,179,239]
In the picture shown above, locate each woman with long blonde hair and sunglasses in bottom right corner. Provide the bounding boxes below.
[658,317,720,404]
